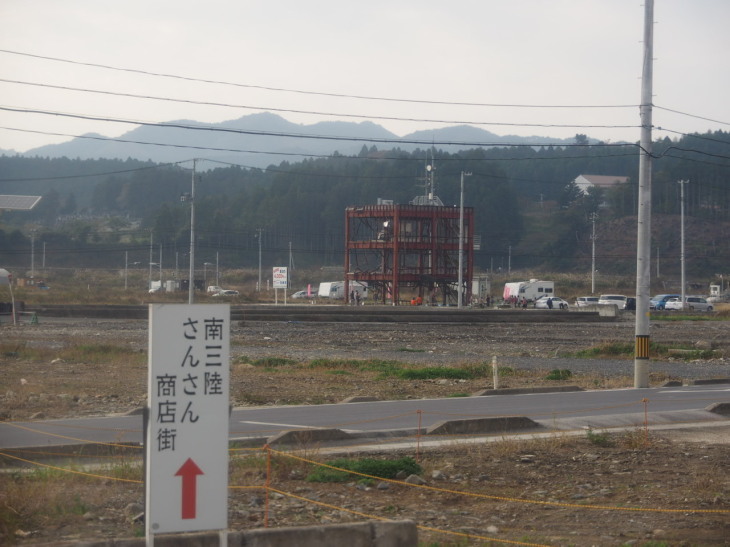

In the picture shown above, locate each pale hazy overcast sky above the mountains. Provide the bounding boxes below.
[0,0,730,157]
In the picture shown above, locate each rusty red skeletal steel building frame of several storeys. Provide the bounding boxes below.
[345,205,474,305]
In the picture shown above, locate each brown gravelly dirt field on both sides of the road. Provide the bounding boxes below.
[0,320,730,546]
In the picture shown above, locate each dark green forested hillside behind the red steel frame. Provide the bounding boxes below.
[0,132,730,275]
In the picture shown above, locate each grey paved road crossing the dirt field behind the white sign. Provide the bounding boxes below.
[0,384,730,449]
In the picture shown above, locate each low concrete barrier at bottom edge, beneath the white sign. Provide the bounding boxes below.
[38,520,418,547]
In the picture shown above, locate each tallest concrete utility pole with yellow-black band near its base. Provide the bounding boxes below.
[634,0,654,388]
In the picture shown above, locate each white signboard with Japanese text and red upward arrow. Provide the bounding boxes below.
[145,304,231,538]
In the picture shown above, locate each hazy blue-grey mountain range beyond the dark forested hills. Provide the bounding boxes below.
[5,112,574,168]
